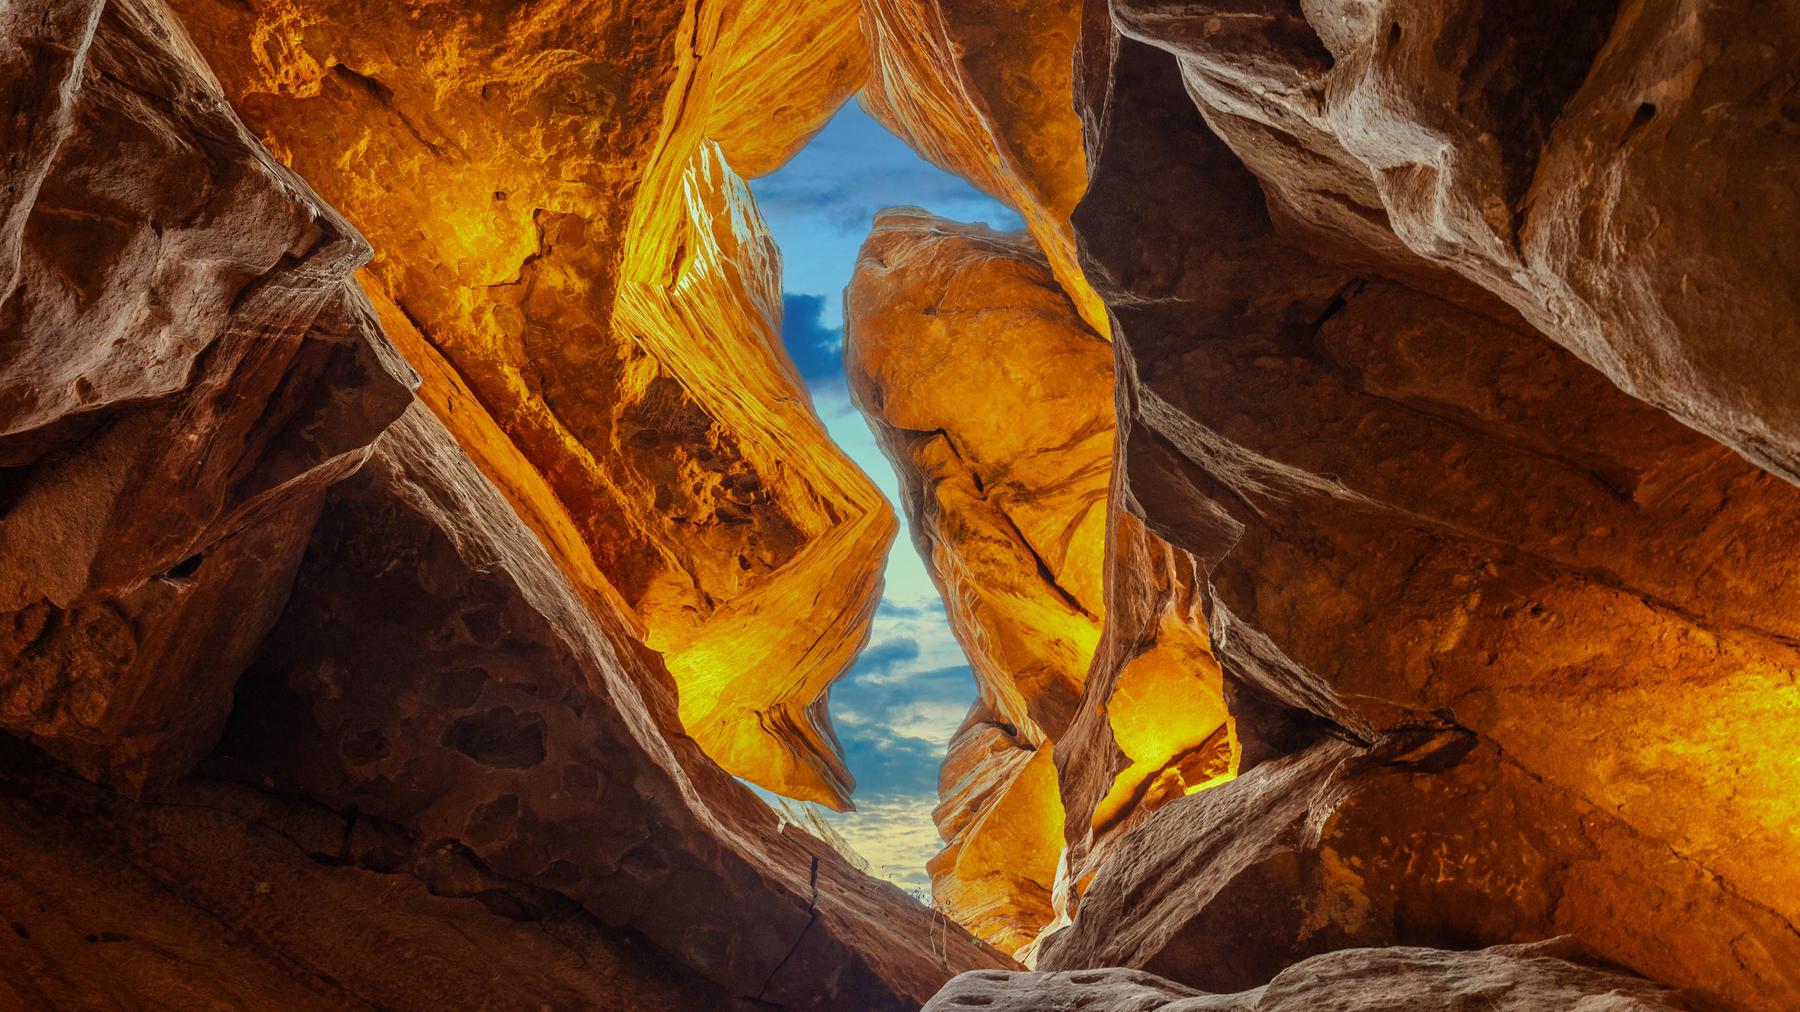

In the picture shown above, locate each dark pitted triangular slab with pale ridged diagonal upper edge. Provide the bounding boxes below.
[220,407,1006,1008]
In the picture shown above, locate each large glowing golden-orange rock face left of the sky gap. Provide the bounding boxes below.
[178,0,893,807]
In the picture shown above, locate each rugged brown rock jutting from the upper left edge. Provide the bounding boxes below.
[0,2,416,791]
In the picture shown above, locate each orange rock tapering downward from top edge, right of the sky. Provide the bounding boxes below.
[862,0,1109,337]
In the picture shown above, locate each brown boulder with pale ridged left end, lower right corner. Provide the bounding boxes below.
[1037,731,1800,1008]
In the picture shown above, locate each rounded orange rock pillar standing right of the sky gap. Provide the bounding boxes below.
[846,209,1229,951]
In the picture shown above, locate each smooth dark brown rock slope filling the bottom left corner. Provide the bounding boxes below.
[0,731,734,1012]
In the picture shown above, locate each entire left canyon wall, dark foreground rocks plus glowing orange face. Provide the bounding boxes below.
[0,0,1013,1010]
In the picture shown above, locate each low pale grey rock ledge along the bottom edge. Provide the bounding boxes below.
[925,940,1694,1012]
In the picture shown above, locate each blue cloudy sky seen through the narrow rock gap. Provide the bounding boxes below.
[751,103,1022,895]
